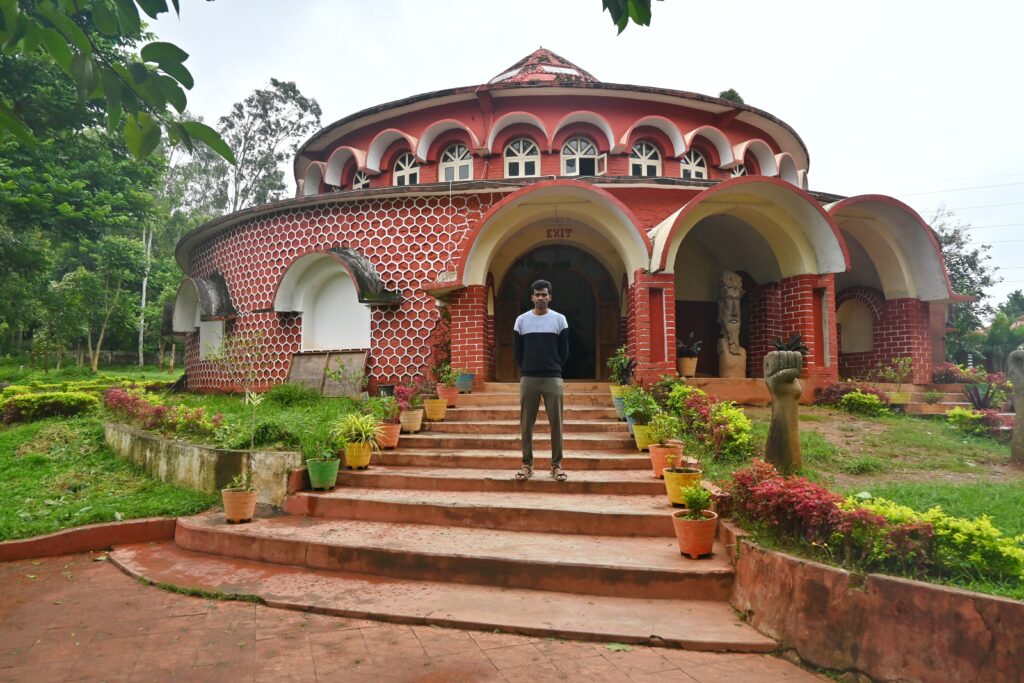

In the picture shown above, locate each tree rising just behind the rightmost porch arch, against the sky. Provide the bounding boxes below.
[931,207,1001,358]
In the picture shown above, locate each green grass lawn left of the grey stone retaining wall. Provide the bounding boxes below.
[0,417,219,541]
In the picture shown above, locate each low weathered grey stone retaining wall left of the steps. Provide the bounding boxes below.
[105,423,305,507]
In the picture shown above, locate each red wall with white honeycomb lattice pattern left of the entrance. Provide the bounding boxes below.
[185,194,502,391]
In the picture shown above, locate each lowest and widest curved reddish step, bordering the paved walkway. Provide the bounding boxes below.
[110,542,777,653]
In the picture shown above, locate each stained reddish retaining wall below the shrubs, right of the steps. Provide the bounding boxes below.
[722,523,1024,683]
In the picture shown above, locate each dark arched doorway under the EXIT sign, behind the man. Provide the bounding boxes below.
[495,245,620,382]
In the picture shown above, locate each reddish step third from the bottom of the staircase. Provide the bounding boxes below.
[285,486,675,538]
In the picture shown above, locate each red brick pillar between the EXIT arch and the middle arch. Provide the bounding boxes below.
[627,268,676,385]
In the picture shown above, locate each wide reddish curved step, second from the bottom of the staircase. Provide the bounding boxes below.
[174,512,734,600]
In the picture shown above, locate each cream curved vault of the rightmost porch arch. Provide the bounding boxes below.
[825,196,952,301]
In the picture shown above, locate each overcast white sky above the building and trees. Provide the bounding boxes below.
[151,0,1024,311]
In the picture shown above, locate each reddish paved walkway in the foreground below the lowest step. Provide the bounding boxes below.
[0,554,825,683]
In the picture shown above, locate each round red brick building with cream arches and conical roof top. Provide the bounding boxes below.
[170,49,954,390]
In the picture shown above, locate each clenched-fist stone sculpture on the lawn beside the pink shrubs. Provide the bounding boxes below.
[765,351,804,474]
